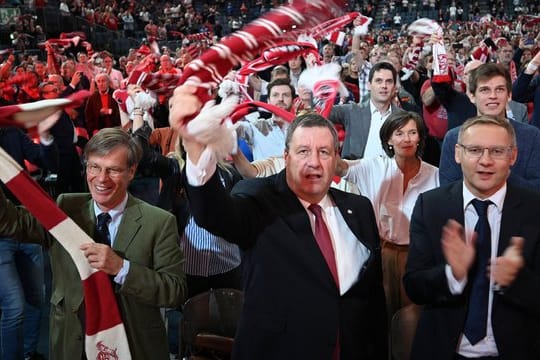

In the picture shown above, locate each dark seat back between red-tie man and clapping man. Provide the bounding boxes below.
[390,304,422,360]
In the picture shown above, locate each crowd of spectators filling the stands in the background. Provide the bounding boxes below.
[0,0,540,358]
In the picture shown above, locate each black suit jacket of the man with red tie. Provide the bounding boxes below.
[187,171,387,360]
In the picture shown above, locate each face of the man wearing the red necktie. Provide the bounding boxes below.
[285,127,337,204]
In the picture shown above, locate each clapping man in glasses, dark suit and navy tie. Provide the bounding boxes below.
[403,115,540,360]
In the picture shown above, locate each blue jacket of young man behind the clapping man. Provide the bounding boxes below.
[439,120,540,190]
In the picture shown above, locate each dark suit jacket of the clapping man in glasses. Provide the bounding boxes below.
[403,182,540,360]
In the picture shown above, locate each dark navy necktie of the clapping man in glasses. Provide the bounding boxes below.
[464,199,493,345]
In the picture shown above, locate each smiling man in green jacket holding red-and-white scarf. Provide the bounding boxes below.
[0,129,186,360]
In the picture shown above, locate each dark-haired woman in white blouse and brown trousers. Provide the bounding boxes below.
[337,111,439,319]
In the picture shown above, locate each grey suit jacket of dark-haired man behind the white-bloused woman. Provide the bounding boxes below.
[328,102,397,159]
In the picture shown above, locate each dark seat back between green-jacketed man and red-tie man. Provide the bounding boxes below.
[181,289,244,358]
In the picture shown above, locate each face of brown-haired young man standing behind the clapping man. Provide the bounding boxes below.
[469,76,512,117]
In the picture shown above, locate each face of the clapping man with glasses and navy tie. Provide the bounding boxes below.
[455,124,517,199]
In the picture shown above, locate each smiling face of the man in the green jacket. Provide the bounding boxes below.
[86,146,137,211]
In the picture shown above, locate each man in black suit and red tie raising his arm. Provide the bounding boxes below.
[171,87,387,360]
